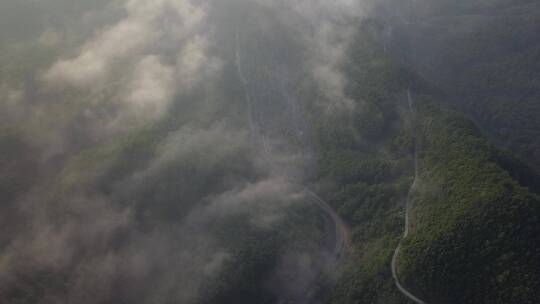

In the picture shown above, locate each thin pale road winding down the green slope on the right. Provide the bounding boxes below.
[392,89,427,304]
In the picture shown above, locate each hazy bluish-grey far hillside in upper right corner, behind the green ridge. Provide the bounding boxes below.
[389,0,540,170]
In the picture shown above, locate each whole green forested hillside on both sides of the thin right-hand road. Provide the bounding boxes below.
[319,22,540,303]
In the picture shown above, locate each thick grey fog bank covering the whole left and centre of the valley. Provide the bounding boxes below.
[0,0,382,303]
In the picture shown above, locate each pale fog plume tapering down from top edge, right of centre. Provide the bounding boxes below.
[252,0,373,110]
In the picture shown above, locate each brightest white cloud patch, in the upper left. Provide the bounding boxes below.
[40,0,217,131]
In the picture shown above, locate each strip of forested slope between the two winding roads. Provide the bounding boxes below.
[316,21,414,304]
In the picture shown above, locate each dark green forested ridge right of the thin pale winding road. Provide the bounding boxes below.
[400,97,540,304]
